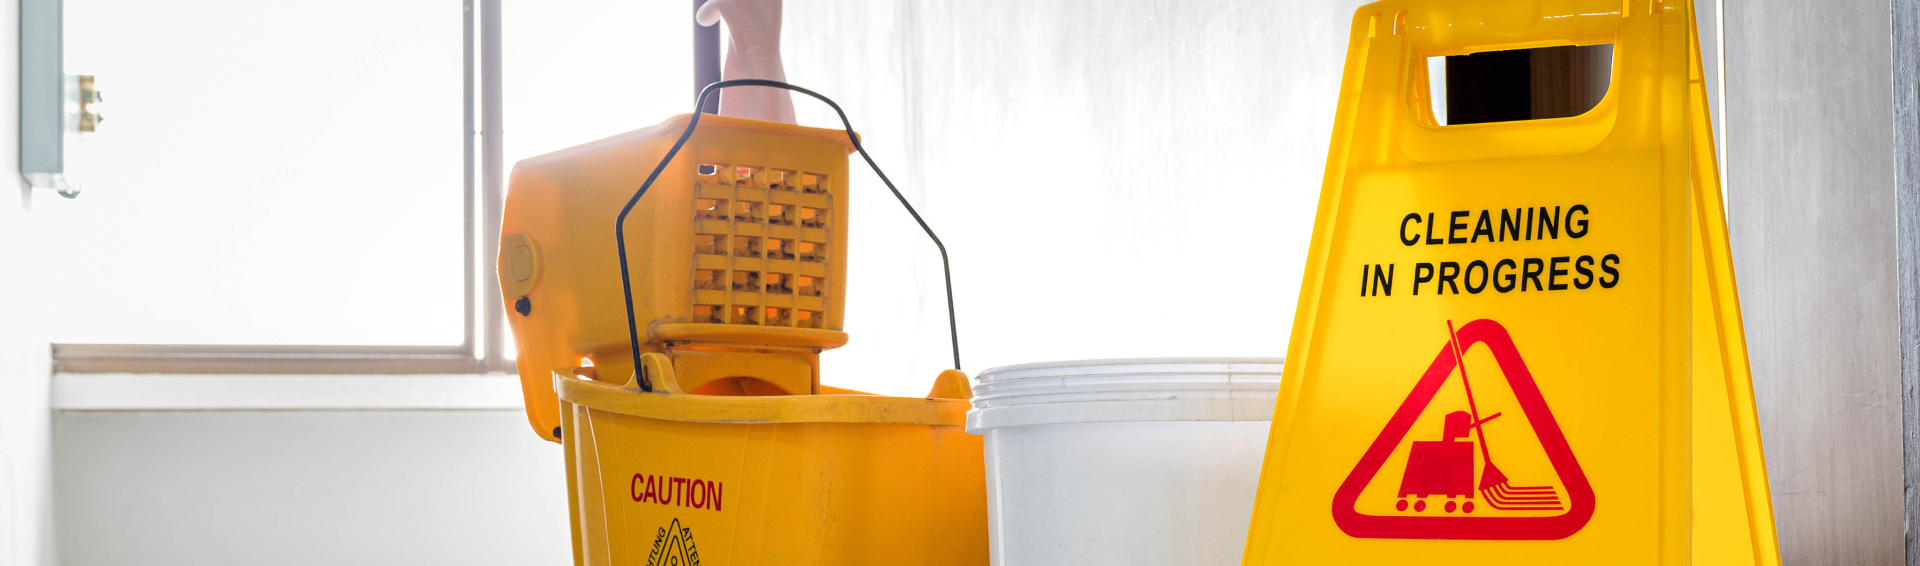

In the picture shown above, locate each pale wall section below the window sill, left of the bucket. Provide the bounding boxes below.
[54,411,572,566]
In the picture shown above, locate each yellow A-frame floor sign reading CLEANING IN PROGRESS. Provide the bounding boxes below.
[1244,0,1780,566]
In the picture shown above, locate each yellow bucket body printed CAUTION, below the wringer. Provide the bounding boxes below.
[555,370,987,566]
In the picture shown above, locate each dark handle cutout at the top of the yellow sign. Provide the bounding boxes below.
[1413,44,1613,127]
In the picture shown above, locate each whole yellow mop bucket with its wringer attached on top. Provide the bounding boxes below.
[499,83,987,566]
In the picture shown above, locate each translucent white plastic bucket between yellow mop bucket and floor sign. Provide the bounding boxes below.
[966,359,1281,566]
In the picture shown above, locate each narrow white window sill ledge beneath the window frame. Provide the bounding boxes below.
[52,374,522,411]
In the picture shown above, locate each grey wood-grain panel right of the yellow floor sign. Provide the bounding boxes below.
[1722,0,1905,564]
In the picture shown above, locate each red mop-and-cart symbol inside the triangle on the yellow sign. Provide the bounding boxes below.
[1394,320,1563,512]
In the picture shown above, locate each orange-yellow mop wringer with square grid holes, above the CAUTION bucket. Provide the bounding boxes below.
[499,115,852,441]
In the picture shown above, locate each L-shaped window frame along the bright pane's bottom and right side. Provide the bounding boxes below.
[52,0,515,374]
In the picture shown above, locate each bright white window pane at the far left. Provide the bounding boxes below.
[35,0,467,345]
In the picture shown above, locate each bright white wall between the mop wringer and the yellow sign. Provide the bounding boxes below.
[783,0,1363,395]
